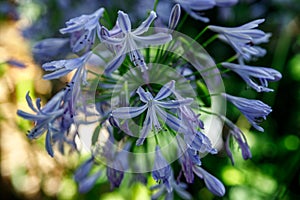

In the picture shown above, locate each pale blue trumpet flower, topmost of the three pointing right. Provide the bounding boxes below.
[208,19,271,63]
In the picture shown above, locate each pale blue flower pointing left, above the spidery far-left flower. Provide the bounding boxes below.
[42,52,92,80]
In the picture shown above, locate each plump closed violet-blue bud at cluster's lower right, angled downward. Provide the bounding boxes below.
[193,165,225,197]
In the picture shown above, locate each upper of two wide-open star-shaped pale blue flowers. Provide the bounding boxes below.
[101,11,172,74]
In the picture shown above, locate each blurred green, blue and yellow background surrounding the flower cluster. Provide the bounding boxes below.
[0,0,300,200]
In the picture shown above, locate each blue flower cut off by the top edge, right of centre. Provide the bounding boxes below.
[174,0,216,22]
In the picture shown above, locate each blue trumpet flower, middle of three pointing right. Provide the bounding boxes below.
[222,63,282,92]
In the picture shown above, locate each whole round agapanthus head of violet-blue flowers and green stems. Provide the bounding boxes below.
[18,0,281,199]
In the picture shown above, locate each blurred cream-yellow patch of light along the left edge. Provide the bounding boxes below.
[0,19,77,199]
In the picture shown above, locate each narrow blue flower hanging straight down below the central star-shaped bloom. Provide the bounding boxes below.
[152,146,173,193]
